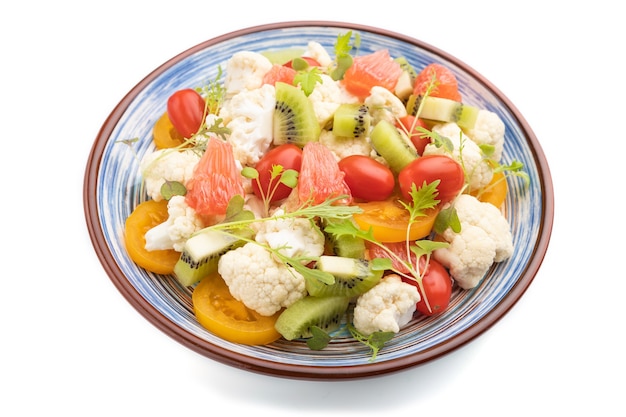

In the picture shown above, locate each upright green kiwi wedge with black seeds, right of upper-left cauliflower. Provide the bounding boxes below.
[273,82,321,147]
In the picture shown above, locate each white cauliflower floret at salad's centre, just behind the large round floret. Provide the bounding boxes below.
[253,209,326,258]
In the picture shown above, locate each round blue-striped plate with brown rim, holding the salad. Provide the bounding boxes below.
[84,21,554,379]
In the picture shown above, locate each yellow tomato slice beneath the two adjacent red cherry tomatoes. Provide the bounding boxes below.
[353,197,439,242]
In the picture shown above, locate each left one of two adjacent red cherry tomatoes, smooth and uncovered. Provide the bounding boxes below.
[339,155,396,201]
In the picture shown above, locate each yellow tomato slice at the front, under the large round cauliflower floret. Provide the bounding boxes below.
[191,274,281,345]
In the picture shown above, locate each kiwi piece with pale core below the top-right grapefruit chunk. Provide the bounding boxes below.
[406,95,480,129]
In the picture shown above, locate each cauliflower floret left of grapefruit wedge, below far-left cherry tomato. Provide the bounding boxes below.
[139,149,200,201]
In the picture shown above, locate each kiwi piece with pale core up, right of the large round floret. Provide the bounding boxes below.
[306,255,383,297]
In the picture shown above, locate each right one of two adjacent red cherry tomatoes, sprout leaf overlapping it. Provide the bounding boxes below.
[398,155,465,204]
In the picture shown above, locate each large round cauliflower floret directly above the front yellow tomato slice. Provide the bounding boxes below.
[217,243,306,316]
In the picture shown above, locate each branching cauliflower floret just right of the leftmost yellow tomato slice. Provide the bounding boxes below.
[145,195,204,252]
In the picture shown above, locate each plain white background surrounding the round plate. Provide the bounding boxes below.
[0,0,626,416]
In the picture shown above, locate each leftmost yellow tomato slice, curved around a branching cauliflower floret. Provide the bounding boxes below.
[124,200,180,274]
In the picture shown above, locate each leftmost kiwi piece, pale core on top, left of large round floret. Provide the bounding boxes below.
[174,230,243,287]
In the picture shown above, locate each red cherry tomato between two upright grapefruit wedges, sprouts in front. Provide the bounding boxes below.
[252,143,302,202]
